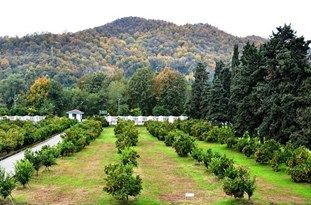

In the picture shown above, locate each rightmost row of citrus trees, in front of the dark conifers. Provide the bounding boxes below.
[175,120,311,183]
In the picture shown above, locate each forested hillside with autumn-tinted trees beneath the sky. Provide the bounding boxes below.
[0,17,265,86]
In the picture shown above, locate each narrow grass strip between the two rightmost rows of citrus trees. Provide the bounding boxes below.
[197,141,311,204]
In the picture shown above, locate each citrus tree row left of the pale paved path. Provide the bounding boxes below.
[0,117,76,156]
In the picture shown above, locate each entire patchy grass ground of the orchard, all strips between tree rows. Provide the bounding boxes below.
[13,127,311,205]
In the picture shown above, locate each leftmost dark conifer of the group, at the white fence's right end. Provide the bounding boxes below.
[188,63,209,118]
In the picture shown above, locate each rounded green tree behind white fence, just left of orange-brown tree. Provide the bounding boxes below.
[129,68,155,115]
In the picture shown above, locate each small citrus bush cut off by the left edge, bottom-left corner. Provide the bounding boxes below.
[0,167,16,199]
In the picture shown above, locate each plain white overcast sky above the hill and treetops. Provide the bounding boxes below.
[0,0,311,39]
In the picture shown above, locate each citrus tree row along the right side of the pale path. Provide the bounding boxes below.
[0,119,102,203]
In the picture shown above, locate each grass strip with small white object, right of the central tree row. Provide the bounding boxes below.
[137,127,226,204]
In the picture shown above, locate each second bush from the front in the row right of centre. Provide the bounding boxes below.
[209,156,233,179]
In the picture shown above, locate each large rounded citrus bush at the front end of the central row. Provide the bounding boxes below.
[104,164,142,200]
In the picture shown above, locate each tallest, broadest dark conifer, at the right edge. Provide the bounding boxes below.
[259,25,310,146]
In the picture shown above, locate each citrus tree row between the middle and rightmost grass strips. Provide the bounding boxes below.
[145,121,255,199]
